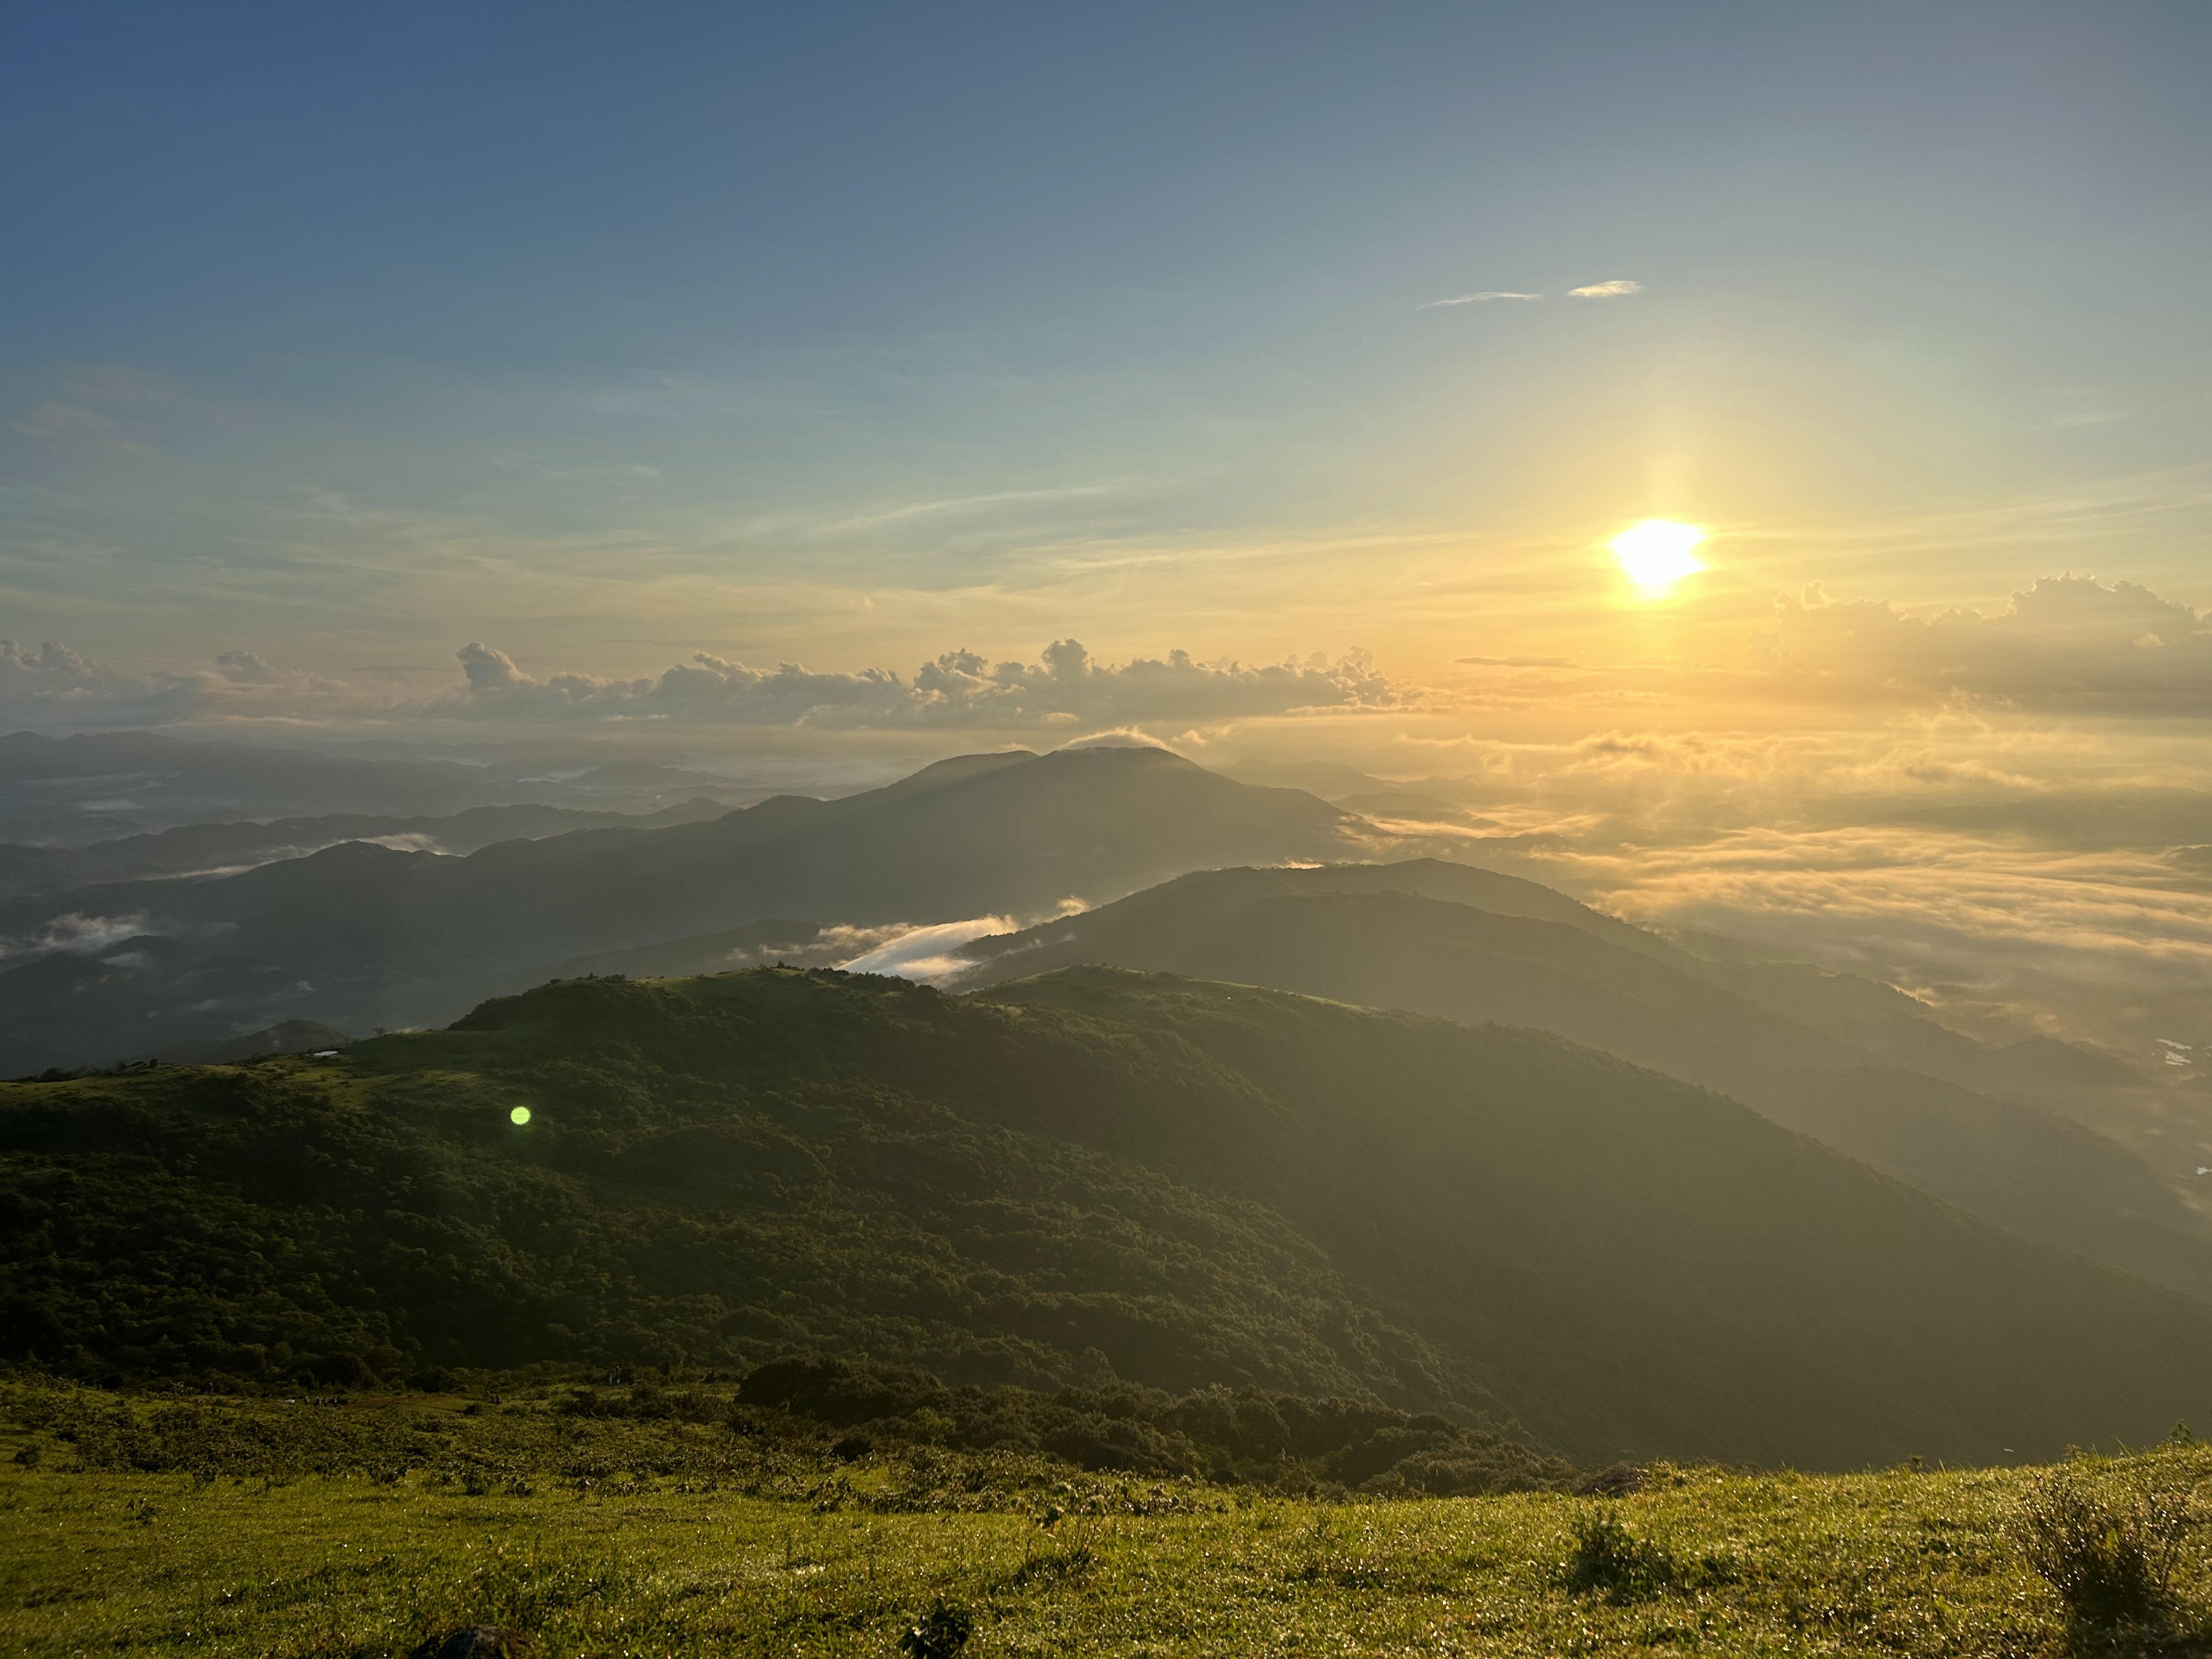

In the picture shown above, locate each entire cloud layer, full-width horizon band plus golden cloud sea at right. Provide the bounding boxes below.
[0,575,2212,1057]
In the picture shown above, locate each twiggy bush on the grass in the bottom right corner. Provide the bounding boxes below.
[2013,1464,2197,1630]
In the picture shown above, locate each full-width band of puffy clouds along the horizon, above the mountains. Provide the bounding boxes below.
[0,575,2212,732]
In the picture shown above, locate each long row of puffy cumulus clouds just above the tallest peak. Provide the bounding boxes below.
[438,639,1418,728]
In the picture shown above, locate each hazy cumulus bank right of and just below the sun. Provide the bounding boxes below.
[1770,575,2212,714]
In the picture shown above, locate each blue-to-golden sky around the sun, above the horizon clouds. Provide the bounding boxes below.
[0,2,2212,703]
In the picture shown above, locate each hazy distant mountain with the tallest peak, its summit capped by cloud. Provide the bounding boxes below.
[0,748,1358,1075]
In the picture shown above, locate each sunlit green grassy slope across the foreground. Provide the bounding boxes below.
[0,1398,2212,1659]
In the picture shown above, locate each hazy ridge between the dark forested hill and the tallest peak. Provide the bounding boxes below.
[958,860,2212,1299]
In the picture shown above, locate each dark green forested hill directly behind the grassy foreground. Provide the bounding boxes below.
[0,969,2212,1466]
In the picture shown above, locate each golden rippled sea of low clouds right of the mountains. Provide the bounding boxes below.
[1369,703,2212,1053]
